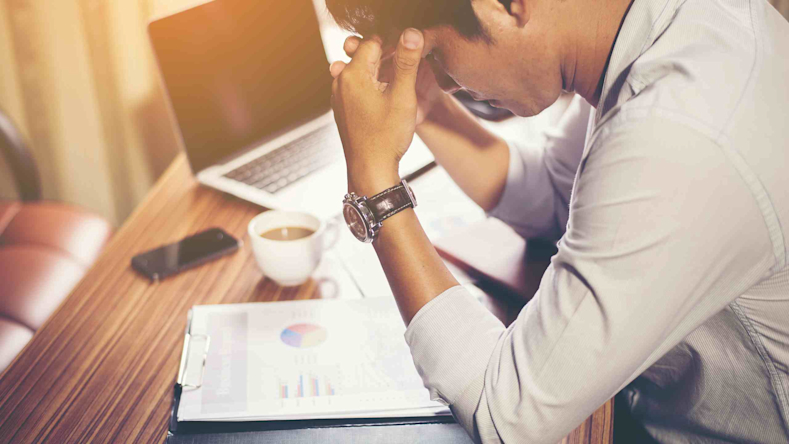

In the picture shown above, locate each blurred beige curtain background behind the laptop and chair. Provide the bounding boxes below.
[0,0,789,225]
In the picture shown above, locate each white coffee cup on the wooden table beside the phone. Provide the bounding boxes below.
[247,210,331,287]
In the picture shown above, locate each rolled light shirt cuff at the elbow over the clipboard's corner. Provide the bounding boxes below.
[405,286,505,411]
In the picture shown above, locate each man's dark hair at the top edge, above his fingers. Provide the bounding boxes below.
[326,0,490,39]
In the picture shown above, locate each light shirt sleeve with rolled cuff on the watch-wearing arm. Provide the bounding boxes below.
[406,119,776,444]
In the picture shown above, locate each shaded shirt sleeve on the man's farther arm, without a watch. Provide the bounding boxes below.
[489,96,592,239]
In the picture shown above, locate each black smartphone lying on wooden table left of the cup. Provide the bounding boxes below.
[132,228,241,281]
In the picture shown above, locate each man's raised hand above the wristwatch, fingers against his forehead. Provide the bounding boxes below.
[331,29,424,195]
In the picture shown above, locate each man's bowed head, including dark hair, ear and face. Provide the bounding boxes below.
[326,0,566,116]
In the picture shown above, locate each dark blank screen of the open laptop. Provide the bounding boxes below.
[148,0,332,172]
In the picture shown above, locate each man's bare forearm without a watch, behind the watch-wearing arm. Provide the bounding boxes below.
[417,95,509,211]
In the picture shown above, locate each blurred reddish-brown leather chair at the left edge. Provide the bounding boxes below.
[0,110,112,373]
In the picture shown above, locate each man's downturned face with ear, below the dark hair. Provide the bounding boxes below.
[424,0,562,117]
